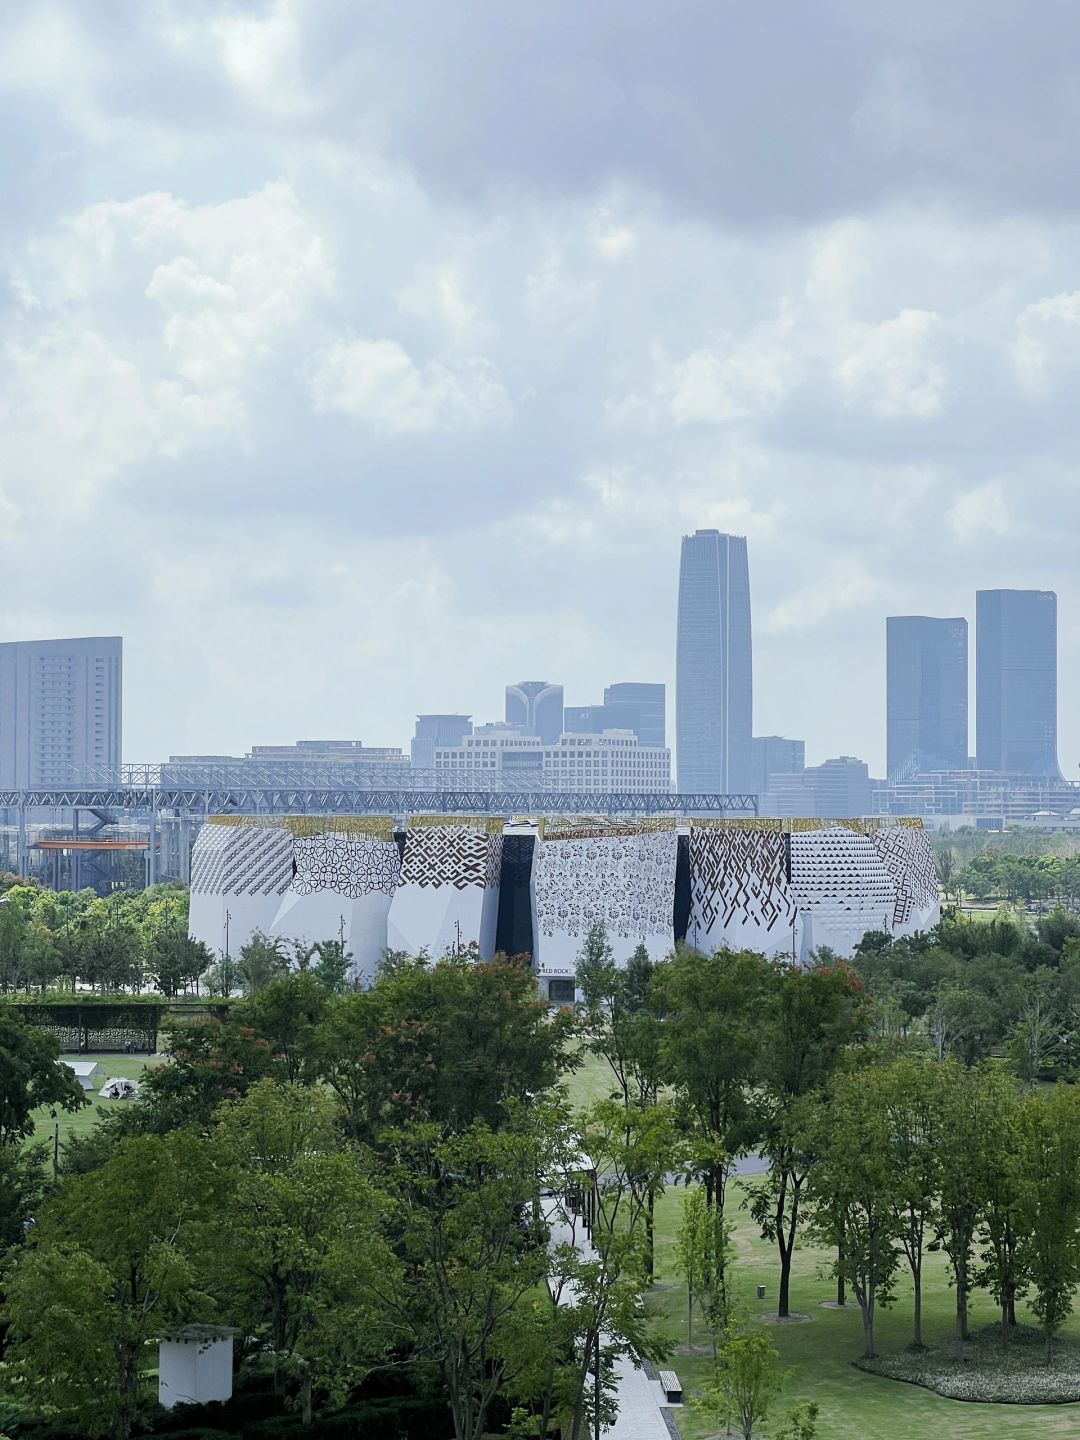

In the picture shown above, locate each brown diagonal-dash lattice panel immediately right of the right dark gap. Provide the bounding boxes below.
[690,824,795,935]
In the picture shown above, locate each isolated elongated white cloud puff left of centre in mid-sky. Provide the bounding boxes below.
[308,340,511,435]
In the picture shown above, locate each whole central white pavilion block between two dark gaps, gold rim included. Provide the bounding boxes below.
[533,822,678,976]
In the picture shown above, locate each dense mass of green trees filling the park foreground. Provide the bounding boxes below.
[10,894,1080,1440]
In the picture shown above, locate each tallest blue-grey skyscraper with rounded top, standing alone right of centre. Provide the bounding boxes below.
[675,530,753,793]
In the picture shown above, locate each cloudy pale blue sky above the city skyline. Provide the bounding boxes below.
[0,0,1080,776]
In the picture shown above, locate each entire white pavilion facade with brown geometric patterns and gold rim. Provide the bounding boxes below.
[189,815,939,979]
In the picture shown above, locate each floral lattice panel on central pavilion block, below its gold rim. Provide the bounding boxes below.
[536,828,677,943]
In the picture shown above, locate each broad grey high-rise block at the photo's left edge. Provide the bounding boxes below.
[0,635,124,789]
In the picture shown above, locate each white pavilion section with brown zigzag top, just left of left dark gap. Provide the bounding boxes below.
[387,816,503,960]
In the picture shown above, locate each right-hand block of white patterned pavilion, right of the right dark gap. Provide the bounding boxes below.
[687,819,939,963]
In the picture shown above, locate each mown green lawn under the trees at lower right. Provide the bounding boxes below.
[651,1182,1080,1440]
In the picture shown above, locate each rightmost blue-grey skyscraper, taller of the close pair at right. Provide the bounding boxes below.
[975,590,1060,778]
